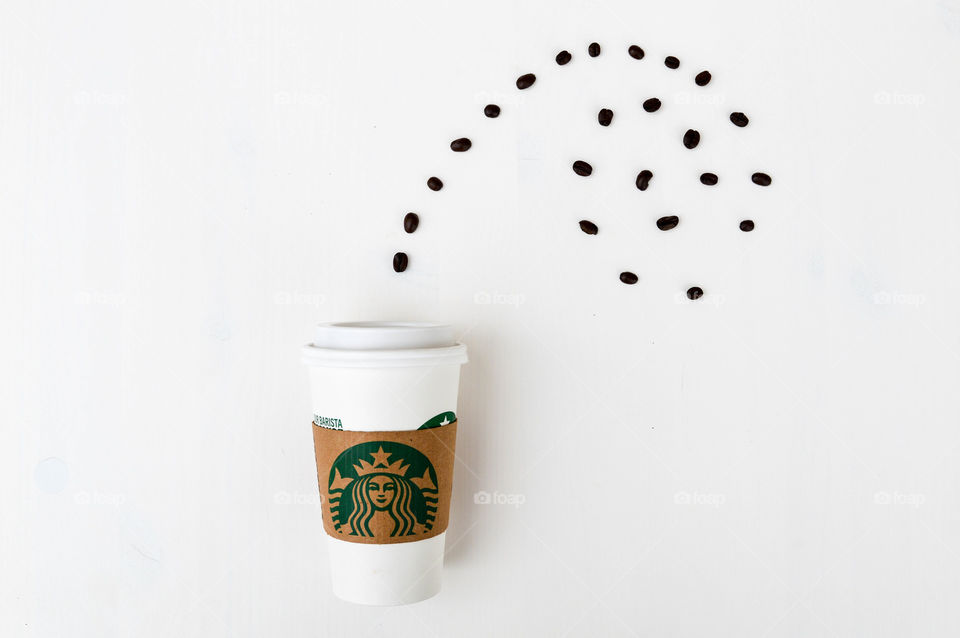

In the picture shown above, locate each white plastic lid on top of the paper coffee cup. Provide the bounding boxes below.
[303,321,467,368]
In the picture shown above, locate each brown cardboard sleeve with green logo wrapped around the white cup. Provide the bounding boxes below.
[313,421,457,545]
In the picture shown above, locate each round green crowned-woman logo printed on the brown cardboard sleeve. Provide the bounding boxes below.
[329,441,437,538]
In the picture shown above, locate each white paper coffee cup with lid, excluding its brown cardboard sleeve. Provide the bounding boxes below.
[302,322,467,605]
